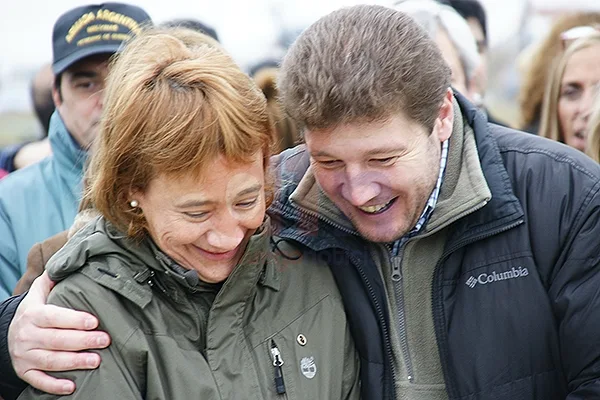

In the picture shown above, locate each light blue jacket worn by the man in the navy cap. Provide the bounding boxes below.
[0,112,87,301]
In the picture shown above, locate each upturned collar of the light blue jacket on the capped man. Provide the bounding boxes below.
[48,111,88,182]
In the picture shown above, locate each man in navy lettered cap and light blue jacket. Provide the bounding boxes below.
[0,3,150,300]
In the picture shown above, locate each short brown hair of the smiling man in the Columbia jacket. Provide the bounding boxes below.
[279,5,450,130]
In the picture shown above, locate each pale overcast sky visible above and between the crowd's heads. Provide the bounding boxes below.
[0,0,600,114]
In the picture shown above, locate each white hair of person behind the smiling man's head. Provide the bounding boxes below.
[392,0,480,84]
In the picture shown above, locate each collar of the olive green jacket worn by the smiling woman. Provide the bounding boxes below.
[46,217,279,307]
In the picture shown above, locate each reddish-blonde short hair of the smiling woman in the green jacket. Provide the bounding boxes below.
[88,28,273,238]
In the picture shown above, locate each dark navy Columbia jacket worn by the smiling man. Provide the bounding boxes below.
[270,95,600,400]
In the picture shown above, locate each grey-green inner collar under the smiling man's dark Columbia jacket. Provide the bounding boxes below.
[290,99,492,241]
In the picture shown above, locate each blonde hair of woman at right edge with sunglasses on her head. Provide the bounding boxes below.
[539,32,600,142]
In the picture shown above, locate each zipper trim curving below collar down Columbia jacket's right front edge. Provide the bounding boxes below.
[431,218,524,399]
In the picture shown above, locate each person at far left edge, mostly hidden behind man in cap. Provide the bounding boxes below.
[0,64,55,172]
